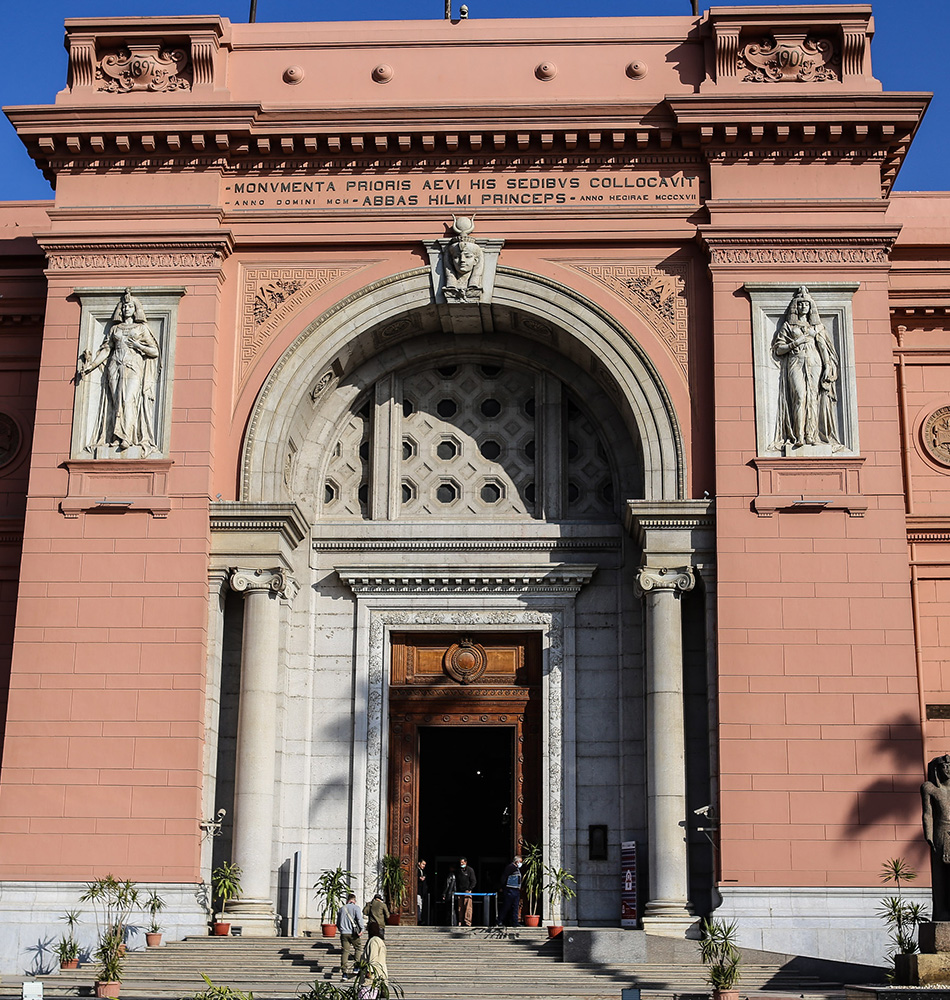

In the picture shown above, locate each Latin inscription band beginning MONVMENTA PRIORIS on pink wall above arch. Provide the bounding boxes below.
[221,170,700,211]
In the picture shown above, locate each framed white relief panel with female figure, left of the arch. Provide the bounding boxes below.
[71,288,184,459]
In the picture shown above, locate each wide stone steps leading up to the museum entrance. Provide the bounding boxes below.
[13,927,844,1000]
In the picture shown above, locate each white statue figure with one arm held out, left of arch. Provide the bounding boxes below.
[77,288,161,458]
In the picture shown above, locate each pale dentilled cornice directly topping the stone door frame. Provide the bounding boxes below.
[335,564,597,596]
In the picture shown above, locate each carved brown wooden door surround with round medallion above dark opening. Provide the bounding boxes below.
[388,632,541,923]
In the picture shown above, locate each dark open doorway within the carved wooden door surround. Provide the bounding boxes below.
[419,726,516,924]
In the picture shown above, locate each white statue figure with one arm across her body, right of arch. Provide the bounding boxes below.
[771,285,844,451]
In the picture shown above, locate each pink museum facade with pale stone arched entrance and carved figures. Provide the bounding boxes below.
[0,6,950,971]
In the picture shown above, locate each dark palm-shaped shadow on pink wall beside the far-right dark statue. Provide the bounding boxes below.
[848,713,926,866]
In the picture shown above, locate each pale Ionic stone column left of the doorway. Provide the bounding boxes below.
[224,569,295,937]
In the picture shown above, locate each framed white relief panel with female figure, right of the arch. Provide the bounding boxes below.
[745,282,859,458]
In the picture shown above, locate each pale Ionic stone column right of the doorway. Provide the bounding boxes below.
[637,566,695,937]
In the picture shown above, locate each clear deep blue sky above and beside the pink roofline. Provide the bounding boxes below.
[0,0,950,201]
